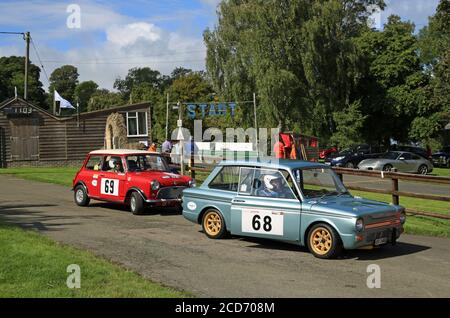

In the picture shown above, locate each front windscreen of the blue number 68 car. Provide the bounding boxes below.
[293,168,348,199]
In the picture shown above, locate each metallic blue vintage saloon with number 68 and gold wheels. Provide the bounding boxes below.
[183,160,406,258]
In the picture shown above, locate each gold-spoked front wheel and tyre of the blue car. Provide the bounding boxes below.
[307,223,343,259]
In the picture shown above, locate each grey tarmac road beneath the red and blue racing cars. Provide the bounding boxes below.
[0,176,450,297]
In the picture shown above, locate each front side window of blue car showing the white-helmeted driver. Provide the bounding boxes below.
[253,169,296,199]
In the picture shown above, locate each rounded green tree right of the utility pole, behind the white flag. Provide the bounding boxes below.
[48,65,79,106]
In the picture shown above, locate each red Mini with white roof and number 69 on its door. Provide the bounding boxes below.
[73,149,195,214]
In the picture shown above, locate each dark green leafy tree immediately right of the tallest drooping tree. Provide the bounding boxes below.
[355,16,428,145]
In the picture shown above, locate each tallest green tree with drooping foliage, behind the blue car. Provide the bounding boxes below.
[204,0,384,139]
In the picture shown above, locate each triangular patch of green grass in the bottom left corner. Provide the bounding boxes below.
[0,223,190,297]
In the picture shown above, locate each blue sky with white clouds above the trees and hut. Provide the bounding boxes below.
[0,0,439,90]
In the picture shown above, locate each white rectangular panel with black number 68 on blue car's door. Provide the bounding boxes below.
[242,209,284,235]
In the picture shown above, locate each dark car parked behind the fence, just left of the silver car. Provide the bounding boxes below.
[325,144,381,168]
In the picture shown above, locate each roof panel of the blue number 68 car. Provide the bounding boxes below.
[219,158,329,169]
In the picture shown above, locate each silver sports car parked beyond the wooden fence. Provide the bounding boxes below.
[358,151,433,174]
